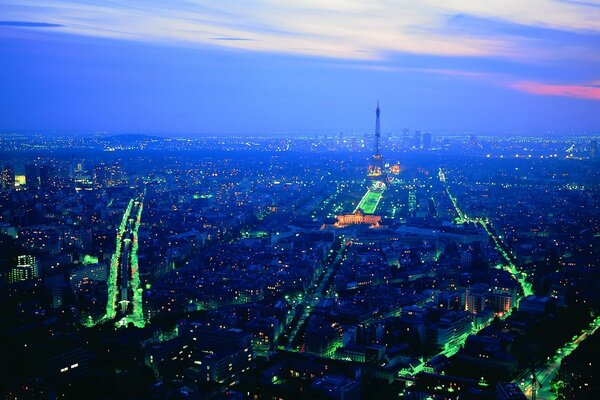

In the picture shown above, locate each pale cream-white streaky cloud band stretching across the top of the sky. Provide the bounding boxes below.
[0,0,600,61]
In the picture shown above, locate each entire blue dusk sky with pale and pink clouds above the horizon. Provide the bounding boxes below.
[0,0,600,134]
